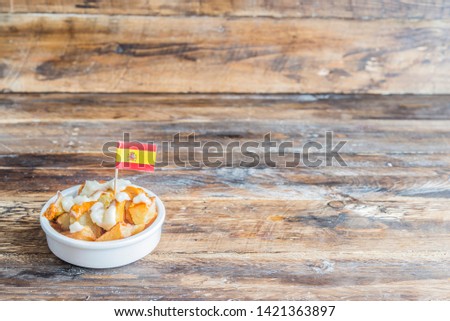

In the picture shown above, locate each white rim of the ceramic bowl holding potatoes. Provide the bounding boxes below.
[39,184,166,250]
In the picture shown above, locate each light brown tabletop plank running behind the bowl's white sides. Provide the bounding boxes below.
[0,198,450,255]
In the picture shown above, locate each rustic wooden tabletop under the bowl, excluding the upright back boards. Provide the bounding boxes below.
[0,94,450,300]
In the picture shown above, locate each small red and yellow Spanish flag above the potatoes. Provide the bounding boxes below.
[116,142,156,172]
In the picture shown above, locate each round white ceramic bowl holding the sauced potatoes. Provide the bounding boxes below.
[40,185,166,269]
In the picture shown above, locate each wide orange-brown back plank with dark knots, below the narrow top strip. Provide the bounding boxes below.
[0,14,450,94]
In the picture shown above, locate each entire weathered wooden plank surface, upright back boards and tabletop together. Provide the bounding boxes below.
[0,0,450,300]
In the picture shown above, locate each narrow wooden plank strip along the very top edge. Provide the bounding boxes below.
[0,0,450,19]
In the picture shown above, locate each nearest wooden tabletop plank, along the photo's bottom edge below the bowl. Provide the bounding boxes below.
[0,254,449,301]
